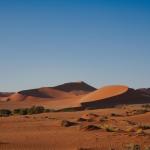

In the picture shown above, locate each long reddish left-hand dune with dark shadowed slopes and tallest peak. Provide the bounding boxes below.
[6,82,95,101]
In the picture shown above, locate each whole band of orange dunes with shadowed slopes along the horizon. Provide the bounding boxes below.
[0,82,150,108]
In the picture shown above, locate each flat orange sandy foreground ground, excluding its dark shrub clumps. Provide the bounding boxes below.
[0,106,150,150]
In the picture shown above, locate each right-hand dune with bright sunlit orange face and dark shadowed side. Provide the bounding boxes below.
[81,85,150,108]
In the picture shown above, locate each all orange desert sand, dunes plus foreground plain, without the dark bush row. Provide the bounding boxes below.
[0,82,150,150]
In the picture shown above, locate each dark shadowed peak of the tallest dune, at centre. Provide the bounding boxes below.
[53,81,96,94]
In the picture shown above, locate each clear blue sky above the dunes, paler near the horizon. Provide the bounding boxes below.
[0,0,150,91]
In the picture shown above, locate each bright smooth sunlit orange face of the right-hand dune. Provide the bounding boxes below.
[81,85,128,102]
